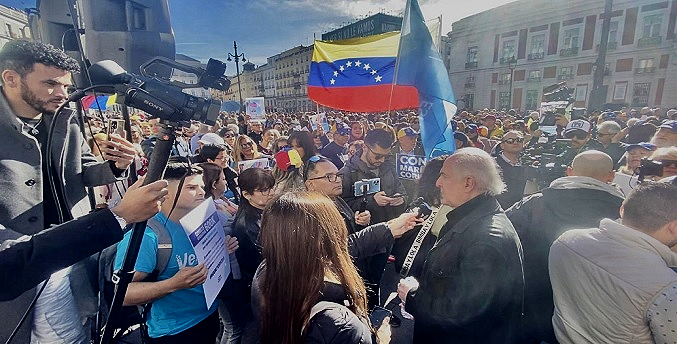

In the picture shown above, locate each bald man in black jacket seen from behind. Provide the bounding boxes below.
[506,150,623,344]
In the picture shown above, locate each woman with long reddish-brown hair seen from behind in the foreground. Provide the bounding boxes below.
[256,191,389,344]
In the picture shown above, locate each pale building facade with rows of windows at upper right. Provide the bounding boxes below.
[445,0,677,110]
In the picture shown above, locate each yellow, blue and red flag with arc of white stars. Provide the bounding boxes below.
[308,32,418,112]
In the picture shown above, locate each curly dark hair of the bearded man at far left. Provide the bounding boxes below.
[0,40,80,77]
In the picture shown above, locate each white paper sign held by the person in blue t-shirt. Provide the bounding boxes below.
[179,198,230,309]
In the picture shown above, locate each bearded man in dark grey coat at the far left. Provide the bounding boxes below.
[0,40,135,343]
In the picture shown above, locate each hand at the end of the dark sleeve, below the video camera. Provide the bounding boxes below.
[111,177,168,223]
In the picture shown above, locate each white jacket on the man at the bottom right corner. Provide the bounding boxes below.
[549,219,677,344]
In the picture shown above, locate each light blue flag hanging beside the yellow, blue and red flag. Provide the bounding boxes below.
[395,0,456,157]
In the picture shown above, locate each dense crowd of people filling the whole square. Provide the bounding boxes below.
[0,41,677,344]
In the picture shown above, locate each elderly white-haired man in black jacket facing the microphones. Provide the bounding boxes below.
[398,147,524,343]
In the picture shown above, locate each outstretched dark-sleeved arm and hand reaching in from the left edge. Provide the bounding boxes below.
[0,179,167,300]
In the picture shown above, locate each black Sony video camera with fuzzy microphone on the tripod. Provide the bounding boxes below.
[89,56,230,126]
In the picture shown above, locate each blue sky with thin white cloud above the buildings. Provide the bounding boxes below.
[0,0,514,69]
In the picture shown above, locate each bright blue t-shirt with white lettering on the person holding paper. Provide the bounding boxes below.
[115,212,218,338]
